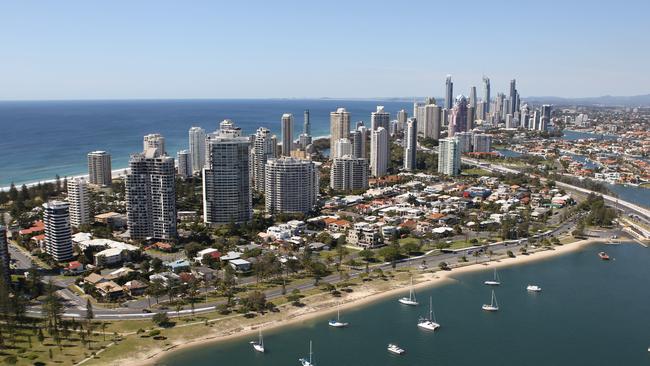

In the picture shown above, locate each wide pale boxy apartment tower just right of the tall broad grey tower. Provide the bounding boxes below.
[264,157,319,214]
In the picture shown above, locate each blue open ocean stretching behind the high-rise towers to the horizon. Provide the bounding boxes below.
[0,99,412,187]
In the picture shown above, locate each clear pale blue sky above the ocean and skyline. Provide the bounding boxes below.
[0,0,650,100]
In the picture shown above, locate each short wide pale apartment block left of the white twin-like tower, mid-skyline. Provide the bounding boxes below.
[330,155,368,192]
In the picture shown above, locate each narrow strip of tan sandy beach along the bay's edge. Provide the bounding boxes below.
[117,238,606,366]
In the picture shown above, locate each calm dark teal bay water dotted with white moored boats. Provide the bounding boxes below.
[160,244,650,366]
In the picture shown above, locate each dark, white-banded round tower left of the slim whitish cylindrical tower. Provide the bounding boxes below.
[43,201,72,262]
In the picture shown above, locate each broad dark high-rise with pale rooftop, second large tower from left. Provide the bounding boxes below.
[125,146,176,240]
